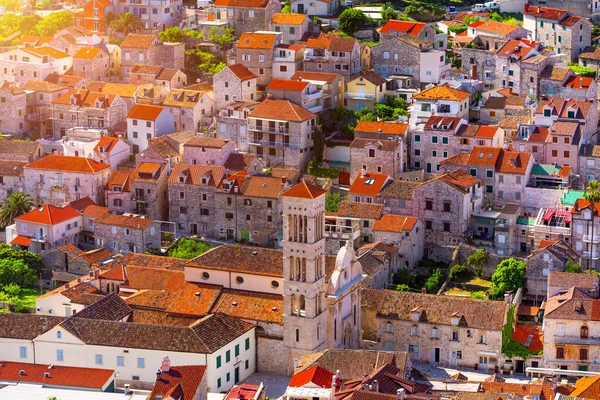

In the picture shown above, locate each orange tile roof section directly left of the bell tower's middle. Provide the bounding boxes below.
[211,289,283,325]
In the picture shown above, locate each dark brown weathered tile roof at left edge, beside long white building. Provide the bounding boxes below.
[0,313,65,340]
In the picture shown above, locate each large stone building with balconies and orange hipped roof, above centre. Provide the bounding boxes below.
[247,99,317,169]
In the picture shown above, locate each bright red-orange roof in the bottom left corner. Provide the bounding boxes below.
[0,361,115,391]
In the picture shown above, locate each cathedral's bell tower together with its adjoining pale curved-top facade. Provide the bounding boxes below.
[282,182,365,373]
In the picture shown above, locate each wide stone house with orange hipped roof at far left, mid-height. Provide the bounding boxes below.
[25,154,110,205]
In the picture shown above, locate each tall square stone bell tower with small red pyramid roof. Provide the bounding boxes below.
[281,182,327,374]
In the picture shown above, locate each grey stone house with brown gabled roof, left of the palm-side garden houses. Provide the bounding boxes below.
[412,170,483,245]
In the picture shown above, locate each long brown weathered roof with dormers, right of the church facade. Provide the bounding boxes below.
[361,289,508,331]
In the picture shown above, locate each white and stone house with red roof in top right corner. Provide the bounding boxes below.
[523,4,592,62]
